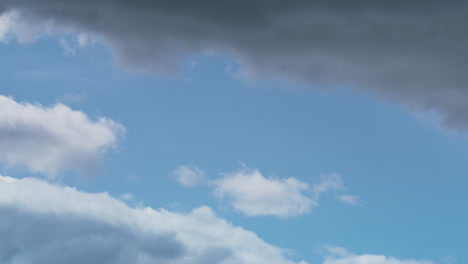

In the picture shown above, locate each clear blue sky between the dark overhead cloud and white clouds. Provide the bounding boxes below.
[0,38,468,263]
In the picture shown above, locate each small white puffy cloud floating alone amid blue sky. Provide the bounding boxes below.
[211,168,343,217]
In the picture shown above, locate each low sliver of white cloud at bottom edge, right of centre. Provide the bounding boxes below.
[323,246,433,264]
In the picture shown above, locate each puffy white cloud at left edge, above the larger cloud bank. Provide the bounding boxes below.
[0,95,125,177]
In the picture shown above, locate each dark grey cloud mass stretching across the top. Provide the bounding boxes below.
[0,0,468,128]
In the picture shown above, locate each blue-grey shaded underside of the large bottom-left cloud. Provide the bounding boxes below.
[0,207,184,264]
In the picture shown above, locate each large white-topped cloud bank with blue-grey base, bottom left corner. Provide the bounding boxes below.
[0,176,305,264]
